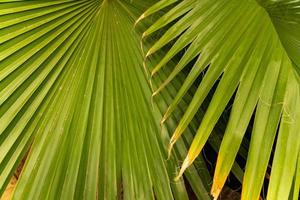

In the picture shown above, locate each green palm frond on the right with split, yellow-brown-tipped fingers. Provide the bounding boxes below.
[136,0,300,200]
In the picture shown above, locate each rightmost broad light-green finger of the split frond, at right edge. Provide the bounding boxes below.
[267,69,300,199]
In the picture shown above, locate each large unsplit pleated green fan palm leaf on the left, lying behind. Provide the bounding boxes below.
[0,0,216,200]
